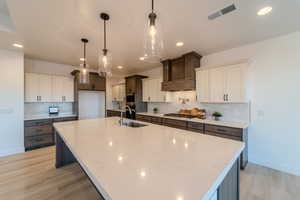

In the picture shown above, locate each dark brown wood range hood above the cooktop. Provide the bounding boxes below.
[161,51,202,92]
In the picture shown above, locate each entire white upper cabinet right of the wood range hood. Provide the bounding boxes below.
[196,64,247,103]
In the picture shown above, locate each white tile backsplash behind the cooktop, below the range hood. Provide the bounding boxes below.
[148,91,251,122]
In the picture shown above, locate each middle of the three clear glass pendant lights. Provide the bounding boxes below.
[98,13,112,76]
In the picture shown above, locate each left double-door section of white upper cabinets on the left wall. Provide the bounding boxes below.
[25,73,52,102]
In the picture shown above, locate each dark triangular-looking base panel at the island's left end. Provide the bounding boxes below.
[55,132,77,168]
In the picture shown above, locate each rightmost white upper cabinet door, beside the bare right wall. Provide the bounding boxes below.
[225,65,245,103]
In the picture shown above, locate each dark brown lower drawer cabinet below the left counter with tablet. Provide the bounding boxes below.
[24,117,78,151]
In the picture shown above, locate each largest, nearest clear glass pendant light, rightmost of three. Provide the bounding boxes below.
[140,0,164,63]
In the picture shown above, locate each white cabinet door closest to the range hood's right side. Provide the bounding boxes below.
[196,70,210,103]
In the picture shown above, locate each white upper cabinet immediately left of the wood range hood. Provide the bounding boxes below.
[143,78,168,102]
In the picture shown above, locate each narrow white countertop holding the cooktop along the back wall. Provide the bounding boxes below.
[137,112,249,129]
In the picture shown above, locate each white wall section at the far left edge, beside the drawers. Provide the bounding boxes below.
[0,49,24,157]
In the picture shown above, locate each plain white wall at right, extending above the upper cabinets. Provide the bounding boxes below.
[202,32,300,175]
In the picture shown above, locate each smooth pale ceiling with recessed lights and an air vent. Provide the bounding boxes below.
[0,0,300,73]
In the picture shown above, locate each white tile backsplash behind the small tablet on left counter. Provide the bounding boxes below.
[24,103,73,116]
